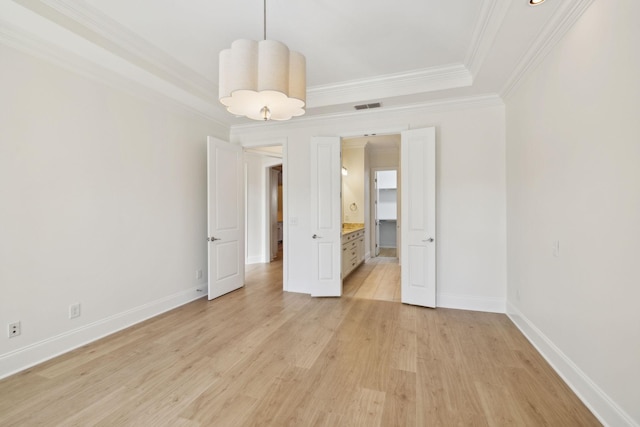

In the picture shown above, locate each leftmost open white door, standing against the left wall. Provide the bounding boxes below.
[207,137,244,300]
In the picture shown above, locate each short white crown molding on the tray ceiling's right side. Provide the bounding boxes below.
[464,0,510,77]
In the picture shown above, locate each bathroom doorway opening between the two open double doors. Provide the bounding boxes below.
[342,134,401,302]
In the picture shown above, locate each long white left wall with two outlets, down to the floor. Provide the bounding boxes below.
[0,46,228,377]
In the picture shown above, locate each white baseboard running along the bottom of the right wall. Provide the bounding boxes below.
[507,303,639,427]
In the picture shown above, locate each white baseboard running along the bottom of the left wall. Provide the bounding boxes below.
[0,284,207,379]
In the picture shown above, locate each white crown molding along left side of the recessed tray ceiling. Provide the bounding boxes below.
[14,0,218,100]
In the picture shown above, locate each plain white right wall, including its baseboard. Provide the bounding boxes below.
[507,0,640,426]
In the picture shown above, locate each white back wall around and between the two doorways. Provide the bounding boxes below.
[231,100,506,312]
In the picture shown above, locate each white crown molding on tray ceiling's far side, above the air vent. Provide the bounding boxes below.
[307,64,473,108]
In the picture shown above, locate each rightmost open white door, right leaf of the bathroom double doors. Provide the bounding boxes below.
[400,128,436,308]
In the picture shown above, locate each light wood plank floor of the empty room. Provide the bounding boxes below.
[0,256,599,427]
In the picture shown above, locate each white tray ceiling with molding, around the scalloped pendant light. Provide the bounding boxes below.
[0,0,581,126]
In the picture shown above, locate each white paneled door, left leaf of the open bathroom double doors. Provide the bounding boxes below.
[309,137,342,297]
